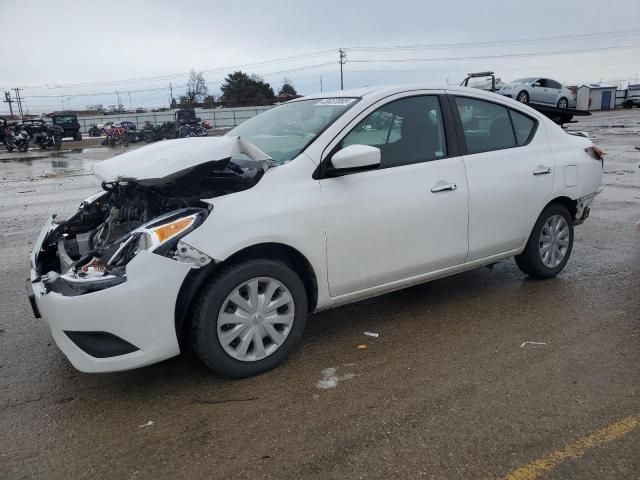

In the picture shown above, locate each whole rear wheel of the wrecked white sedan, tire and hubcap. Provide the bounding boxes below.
[515,203,573,278]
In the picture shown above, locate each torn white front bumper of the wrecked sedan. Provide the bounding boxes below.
[28,218,191,372]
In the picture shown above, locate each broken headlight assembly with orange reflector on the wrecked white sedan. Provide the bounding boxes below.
[42,207,211,296]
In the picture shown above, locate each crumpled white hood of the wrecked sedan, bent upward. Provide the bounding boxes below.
[93,136,270,185]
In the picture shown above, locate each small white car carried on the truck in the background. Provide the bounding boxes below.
[497,77,576,108]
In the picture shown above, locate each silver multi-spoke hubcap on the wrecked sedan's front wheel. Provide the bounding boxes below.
[217,277,295,362]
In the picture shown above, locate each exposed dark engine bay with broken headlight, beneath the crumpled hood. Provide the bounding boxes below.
[35,158,265,296]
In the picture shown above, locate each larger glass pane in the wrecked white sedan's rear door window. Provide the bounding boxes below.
[455,97,517,153]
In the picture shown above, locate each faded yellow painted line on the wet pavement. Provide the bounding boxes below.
[505,415,640,480]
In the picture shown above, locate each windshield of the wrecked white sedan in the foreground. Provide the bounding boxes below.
[227,97,357,163]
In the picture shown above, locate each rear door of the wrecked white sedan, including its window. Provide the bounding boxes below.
[451,96,555,261]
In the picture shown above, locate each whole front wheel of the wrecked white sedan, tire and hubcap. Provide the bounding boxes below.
[190,259,307,378]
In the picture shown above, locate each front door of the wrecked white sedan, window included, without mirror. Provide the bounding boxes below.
[320,95,468,296]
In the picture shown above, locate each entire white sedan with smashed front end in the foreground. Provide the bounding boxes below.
[27,85,602,377]
